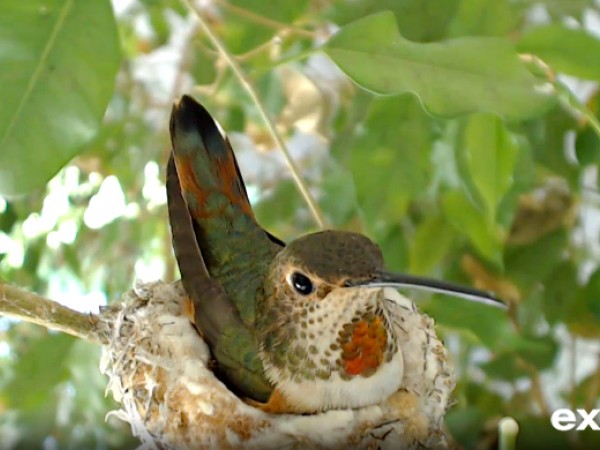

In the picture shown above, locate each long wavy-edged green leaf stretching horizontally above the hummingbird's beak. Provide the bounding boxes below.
[323,12,553,119]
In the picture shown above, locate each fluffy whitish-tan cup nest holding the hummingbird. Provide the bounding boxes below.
[101,282,454,449]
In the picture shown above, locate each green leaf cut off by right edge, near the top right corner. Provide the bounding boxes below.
[517,24,600,80]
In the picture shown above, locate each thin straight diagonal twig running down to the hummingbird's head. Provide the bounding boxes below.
[183,0,325,228]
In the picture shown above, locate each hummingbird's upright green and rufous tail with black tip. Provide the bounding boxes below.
[170,95,283,328]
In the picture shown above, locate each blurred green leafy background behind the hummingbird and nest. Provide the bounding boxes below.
[0,0,600,449]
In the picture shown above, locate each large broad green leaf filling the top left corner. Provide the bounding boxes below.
[0,0,119,195]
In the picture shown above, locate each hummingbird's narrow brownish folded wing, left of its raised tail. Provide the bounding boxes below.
[167,156,271,401]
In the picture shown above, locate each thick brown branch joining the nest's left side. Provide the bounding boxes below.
[0,283,108,344]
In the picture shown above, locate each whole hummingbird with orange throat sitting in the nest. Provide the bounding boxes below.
[166,95,502,413]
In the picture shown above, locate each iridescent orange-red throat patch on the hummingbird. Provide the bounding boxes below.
[339,316,387,377]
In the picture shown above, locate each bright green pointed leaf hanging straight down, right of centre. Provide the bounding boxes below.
[463,114,518,221]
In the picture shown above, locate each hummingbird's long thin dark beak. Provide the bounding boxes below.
[346,271,506,308]
